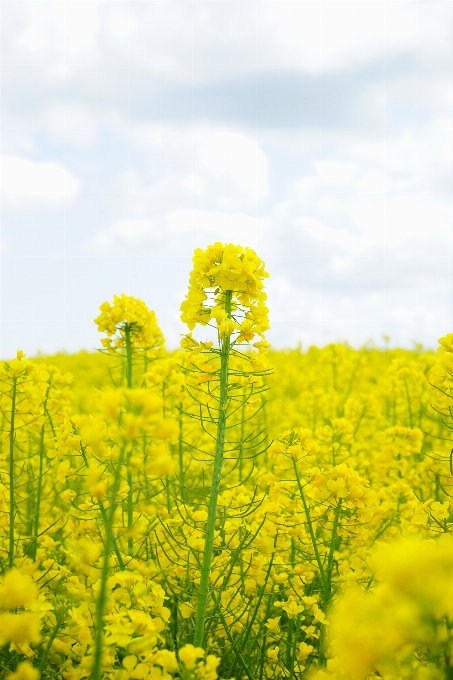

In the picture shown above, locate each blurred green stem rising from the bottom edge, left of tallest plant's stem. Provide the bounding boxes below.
[91,451,123,680]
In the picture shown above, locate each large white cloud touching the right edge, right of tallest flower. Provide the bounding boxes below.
[274,121,453,255]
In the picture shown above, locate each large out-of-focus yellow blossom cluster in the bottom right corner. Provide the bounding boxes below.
[326,539,453,680]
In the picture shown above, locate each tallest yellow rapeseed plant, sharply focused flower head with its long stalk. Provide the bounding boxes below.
[181,243,269,646]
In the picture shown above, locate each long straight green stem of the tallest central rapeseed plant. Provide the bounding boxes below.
[194,290,233,647]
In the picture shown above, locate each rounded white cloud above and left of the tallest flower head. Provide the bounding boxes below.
[104,124,269,218]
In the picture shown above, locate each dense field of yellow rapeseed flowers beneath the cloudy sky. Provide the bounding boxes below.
[0,243,453,680]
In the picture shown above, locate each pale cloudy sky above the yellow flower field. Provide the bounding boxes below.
[0,0,453,358]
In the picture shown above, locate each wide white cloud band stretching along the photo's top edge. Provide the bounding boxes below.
[5,0,450,87]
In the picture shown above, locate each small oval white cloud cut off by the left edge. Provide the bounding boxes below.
[1,156,79,212]
